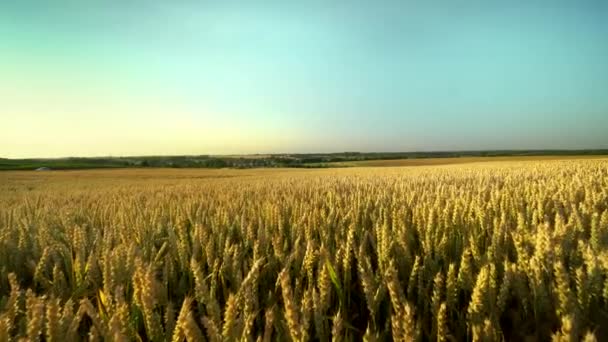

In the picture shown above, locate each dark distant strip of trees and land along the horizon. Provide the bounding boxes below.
[0,149,608,170]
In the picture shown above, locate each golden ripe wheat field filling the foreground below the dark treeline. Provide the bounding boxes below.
[0,159,608,342]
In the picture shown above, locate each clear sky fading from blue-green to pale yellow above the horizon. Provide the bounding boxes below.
[0,0,608,157]
